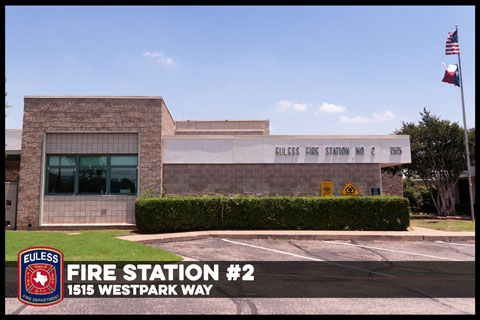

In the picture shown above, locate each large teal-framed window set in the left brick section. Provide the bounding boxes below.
[45,155,138,195]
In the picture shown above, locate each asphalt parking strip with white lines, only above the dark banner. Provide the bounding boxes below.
[150,238,475,261]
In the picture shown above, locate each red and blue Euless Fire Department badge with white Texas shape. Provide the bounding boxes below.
[18,247,63,307]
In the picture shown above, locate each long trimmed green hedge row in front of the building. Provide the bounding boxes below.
[135,196,410,233]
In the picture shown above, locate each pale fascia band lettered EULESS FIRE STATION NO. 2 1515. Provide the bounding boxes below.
[163,135,411,167]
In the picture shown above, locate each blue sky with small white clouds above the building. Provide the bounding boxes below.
[5,6,475,134]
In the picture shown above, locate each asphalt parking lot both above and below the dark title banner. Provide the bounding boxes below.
[5,238,475,314]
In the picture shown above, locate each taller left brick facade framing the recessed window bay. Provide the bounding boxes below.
[18,97,168,229]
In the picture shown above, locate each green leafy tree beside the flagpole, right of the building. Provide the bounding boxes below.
[386,109,475,215]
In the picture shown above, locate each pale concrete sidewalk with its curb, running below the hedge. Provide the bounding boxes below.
[118,227,475,243]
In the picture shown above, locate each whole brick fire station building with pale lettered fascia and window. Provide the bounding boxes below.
[5,96,411,230]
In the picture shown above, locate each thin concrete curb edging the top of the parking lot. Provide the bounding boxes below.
[118,231,475,244]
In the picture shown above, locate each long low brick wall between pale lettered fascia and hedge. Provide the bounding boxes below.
[163,163,380,196]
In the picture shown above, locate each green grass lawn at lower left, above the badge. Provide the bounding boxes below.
[5,230,182,261]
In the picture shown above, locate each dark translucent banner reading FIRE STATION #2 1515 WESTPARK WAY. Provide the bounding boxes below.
[5,261,475,298]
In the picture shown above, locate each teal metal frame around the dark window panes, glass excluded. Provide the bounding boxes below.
[44,153,138,196]
